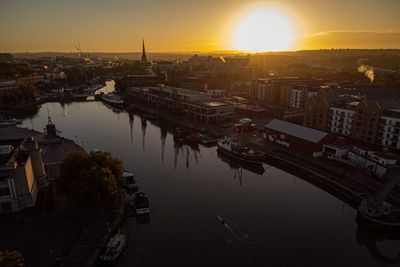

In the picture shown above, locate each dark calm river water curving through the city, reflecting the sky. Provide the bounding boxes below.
[16,83,400,266]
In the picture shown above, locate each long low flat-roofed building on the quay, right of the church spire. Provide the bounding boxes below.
[127,85,234,123]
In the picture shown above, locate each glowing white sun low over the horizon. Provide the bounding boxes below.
[232,7,295,52]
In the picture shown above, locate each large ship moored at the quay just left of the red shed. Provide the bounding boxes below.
[217,139,265,164]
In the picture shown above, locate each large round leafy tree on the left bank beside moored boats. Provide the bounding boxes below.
[57,150,124,206]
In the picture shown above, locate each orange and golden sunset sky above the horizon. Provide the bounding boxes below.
[0,0,400,52]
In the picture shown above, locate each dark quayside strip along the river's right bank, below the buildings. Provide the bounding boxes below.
[128,102,400,208]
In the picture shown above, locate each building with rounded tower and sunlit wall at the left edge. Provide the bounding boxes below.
[0,137,48,214]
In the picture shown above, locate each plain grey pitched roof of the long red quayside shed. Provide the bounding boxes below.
[265,119,328,143]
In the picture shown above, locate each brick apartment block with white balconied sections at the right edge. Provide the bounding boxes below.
[303,91,400,150]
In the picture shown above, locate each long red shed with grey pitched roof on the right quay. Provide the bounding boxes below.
[264,119,335,157]
